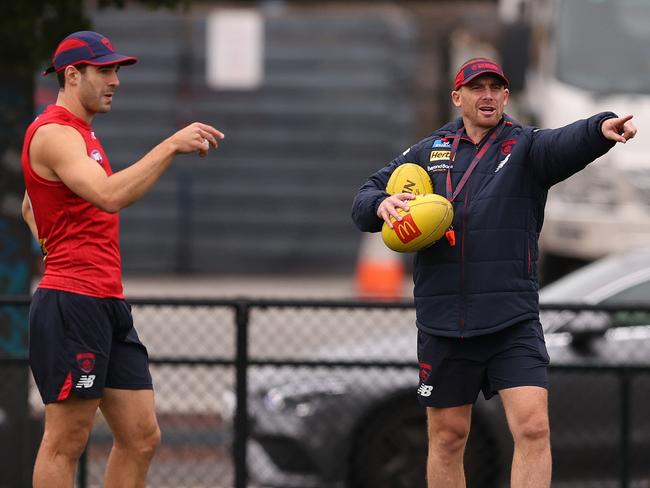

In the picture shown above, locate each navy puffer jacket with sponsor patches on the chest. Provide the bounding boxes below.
[352,112,616,337]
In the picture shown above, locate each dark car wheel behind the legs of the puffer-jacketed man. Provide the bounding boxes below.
[348,397,500,488]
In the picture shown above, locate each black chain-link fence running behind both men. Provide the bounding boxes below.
[0,297,650,488]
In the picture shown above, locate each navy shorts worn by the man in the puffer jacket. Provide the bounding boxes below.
[418,320,549,408]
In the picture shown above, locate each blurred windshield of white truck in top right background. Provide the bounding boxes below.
[555,0,650,93]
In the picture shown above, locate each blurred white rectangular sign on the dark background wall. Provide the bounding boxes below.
[206,10,264,90]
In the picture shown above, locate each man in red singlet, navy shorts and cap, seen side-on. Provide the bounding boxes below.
[22,31,224,488]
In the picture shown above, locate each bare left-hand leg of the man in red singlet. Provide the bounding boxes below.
[32,395,99,488]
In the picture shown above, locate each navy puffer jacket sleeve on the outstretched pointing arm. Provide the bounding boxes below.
[529,112,616,188]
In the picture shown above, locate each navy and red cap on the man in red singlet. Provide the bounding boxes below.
[43,31,138,75]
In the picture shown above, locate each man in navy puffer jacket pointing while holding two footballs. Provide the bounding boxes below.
[352,58,636,488]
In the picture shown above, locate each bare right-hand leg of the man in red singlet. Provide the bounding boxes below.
[99,388,160,488]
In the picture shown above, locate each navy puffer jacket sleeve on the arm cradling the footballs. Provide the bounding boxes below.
[352,155,406,232]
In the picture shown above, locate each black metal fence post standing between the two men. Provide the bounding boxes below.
[233,300,250,488]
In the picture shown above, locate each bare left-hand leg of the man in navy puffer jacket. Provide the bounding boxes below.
[427,405,472,488]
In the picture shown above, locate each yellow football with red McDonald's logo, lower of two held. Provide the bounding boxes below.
[381,193,454,252]
